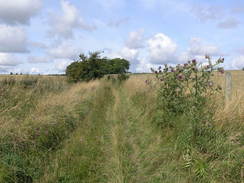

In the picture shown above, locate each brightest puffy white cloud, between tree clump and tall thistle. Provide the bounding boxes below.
[147,33,177,64]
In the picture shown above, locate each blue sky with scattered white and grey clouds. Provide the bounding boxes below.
[0,0,244,74]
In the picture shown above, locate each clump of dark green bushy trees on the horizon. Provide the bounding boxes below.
[66,52,130,82]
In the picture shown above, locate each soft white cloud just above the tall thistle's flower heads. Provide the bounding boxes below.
[188,37,222,56]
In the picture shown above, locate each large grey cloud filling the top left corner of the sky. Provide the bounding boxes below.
[0,0,42,25]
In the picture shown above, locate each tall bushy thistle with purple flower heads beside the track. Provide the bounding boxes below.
[152,56,224,130]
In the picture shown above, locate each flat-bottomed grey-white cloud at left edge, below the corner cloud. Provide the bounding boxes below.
[0,25,28,52]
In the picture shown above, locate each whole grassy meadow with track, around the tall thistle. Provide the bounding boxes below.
[0,71,244,183]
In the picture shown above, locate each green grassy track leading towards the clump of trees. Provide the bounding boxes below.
[39,83,172,183]
